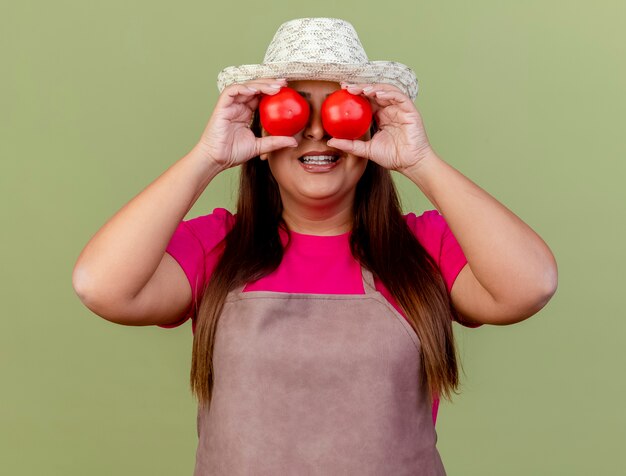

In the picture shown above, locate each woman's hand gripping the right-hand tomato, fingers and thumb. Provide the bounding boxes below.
[328,83,432,172]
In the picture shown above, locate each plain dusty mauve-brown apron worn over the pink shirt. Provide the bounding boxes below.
[194,268,446,476]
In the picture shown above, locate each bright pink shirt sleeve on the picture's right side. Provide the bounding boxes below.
[404,210,482,328]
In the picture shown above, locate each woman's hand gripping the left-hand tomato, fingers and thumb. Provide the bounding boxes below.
[196,79,298,169]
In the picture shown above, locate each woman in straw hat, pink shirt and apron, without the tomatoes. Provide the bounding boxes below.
[74,18,557,475]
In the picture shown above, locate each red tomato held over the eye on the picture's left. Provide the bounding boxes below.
[259,87,310,136]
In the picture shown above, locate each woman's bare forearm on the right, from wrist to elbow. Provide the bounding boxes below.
[402,152,557,303]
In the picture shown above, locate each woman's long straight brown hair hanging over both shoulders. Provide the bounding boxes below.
[191,110,459,406]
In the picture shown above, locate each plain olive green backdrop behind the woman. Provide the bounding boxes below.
[0,0,626,476]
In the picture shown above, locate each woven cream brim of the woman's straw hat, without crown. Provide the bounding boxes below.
[217,61,418,100]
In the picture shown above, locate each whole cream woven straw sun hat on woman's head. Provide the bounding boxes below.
[217,18,417,100]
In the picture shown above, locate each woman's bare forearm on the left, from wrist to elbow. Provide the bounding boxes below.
[72,148,221,299]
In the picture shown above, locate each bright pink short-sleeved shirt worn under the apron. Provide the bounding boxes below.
[159,208,480,423]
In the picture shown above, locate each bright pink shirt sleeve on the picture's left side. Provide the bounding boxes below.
[157,208,234,329]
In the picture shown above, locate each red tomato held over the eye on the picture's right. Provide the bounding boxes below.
[321,89,372,139]
